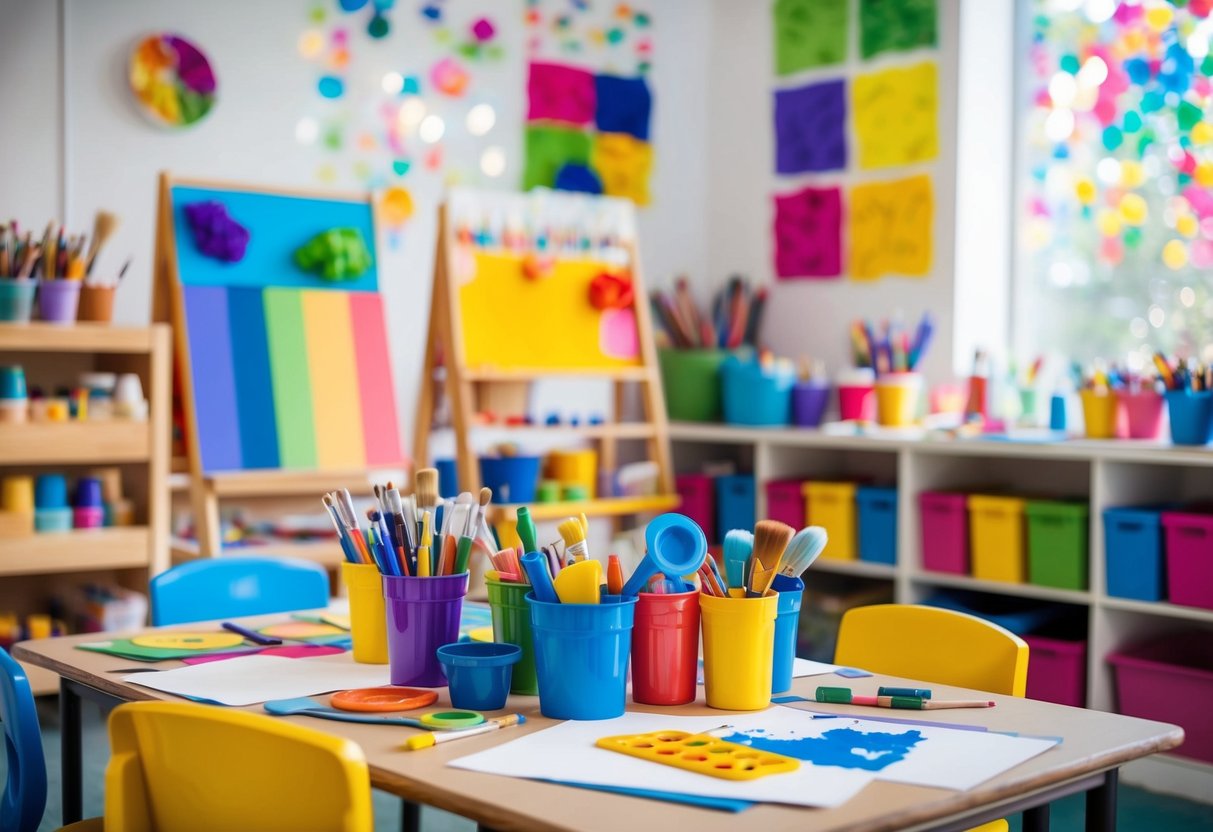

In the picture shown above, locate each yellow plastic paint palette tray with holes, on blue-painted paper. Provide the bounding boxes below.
[594,731,801,780]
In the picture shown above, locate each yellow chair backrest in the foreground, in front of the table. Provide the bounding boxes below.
[106,702,374,832]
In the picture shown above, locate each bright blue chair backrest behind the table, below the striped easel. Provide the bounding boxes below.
[150,558,329,627]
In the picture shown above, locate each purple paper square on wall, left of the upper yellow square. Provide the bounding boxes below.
[775,80,847,173]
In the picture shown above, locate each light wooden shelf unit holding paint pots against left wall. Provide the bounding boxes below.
[0,323,171,694]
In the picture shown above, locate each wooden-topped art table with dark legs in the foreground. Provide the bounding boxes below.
[13,615,1184,832]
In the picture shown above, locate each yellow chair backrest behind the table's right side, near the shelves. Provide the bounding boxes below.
[835,604,1027,696]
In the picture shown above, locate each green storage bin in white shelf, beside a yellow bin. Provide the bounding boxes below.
[1024,500,1090,589]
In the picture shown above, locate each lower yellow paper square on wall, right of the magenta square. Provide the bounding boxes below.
[847,173,934,280]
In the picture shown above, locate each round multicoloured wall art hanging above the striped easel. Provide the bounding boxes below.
[130,33,216,127]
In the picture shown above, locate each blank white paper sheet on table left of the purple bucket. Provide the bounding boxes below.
[123,653,389,706]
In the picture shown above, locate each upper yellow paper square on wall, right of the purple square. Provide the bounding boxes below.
[852,61,939,170]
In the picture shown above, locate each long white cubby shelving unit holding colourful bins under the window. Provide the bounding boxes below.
[670,422,1213,800]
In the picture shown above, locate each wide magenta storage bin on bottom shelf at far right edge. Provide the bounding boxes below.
[1111,632,1213,763]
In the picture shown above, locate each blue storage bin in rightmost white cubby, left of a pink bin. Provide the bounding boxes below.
[1104,506,1169,600]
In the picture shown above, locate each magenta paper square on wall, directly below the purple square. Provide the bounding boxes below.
[774,188,842,279]
